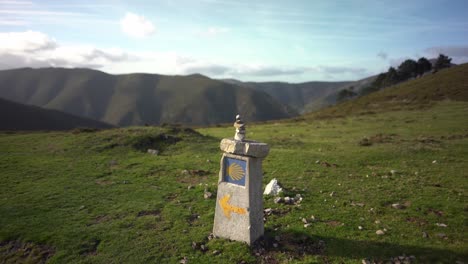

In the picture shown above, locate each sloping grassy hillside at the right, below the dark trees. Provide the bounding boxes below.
[310,64,468,117]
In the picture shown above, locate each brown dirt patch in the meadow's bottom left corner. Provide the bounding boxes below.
[0,240,55,263]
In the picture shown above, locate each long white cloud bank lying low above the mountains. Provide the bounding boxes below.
[0,31,368,81]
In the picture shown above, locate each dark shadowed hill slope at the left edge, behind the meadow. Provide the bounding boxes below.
[0,98,112,130]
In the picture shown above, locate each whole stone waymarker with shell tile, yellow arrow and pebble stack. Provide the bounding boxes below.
[213,115,270,244]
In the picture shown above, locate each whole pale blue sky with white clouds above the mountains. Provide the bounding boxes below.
[0,0,468,83]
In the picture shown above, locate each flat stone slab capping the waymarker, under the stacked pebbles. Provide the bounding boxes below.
[219,138,270,158]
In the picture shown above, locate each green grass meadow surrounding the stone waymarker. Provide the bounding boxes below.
[0,101,468,263]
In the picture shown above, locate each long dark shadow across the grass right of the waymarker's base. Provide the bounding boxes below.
[252,229,468,263]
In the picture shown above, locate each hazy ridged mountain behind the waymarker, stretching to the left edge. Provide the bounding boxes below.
[0,68,294,126]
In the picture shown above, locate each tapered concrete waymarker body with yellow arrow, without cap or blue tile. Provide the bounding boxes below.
[213,153,264,244]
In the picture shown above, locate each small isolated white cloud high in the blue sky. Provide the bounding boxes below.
[120,12,156,38]
